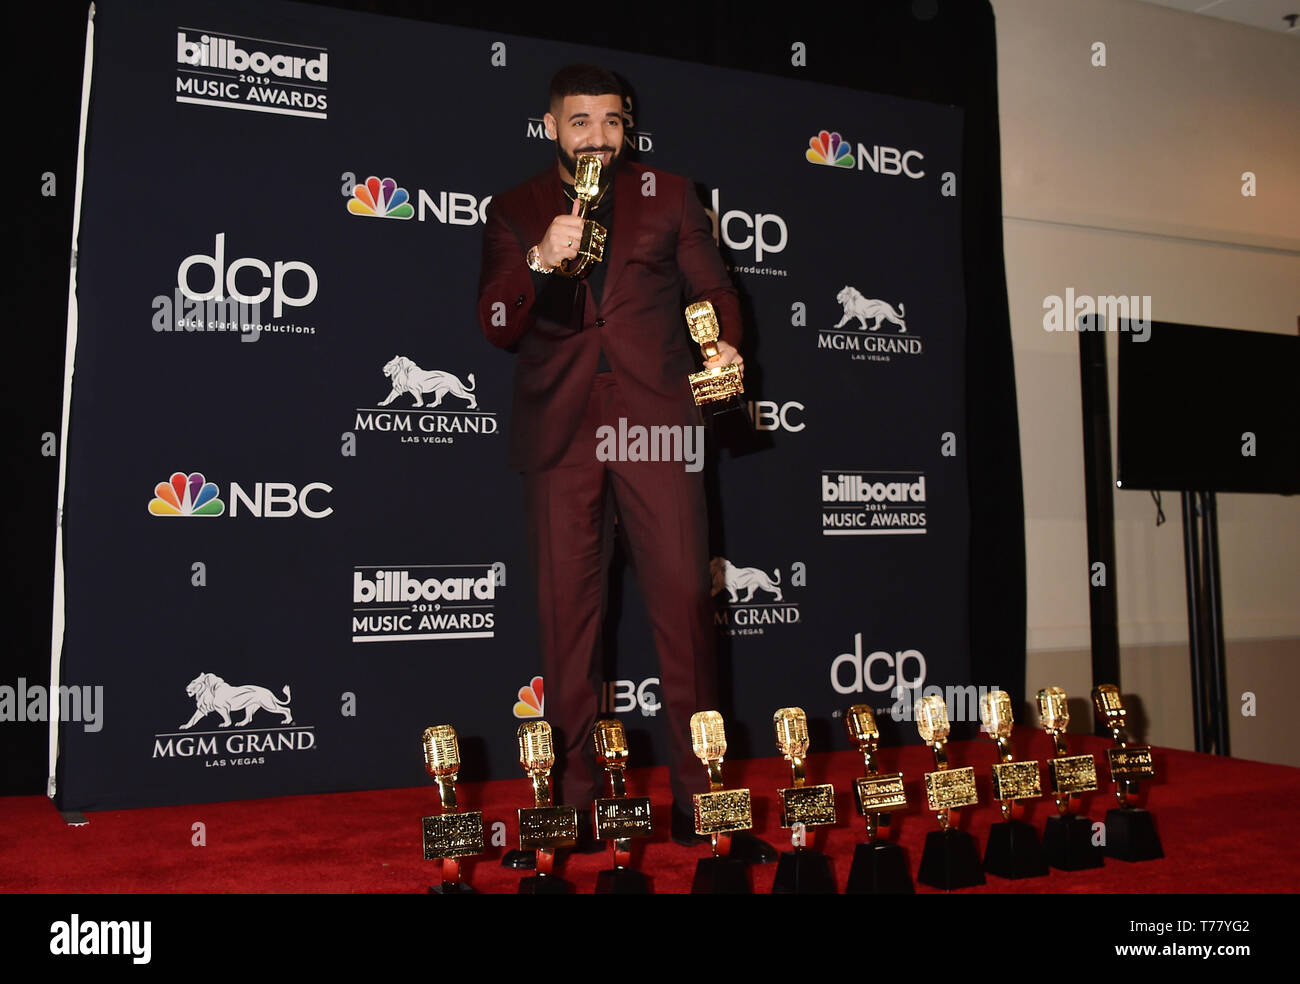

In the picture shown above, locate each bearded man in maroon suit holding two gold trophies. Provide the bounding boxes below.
[478,65,744,842]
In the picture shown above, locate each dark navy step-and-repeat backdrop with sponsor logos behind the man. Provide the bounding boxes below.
[59,3,982,810]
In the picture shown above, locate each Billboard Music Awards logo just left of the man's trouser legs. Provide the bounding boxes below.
[352,563,506,642]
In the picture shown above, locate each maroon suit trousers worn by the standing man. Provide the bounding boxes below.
[524,372,718,810]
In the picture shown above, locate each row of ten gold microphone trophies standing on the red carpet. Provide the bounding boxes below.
[423,684,1164,893]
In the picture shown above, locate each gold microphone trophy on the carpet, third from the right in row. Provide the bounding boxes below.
[979,690,1048,879]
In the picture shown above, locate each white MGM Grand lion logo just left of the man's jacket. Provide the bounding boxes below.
[352,355,498,445]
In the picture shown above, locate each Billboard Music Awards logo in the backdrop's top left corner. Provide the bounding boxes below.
[176,27,329,120]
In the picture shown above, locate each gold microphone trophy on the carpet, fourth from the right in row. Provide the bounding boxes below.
[917,695,984,892]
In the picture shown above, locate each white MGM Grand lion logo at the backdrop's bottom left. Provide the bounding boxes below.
[151,673,316,768]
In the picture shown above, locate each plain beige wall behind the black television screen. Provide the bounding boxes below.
[992,0,1300,764]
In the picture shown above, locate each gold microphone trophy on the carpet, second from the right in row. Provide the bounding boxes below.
[1039,686,1106,871]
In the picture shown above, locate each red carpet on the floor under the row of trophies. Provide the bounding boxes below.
[0,729,1300,893]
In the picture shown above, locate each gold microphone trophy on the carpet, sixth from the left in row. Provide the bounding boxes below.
[844,703,917,896]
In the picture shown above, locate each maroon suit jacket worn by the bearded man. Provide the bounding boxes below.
[478,161,741,472]
